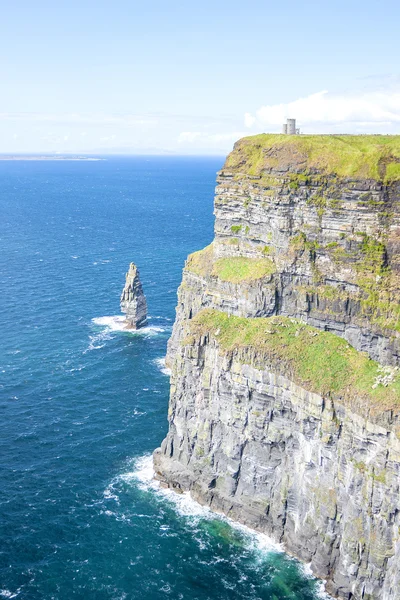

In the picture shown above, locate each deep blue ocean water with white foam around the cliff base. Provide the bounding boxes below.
[0,157,326,600]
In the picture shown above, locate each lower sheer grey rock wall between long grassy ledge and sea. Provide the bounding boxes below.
[154,322,400,600]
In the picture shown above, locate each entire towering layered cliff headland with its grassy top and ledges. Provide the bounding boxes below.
[154,135,400,600]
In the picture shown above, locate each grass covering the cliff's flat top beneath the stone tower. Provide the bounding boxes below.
[224,134,400,183]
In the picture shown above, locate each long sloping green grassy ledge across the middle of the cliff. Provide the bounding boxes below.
[189,309,400,411]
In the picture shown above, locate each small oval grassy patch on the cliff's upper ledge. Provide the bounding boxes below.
[186,244,275,283]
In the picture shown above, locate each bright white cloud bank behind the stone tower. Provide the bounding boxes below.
[244,88,400,133]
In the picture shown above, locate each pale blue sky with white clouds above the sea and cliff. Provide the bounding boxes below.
[0,0,400,155]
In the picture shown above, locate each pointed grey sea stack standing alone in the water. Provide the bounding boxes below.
[121,263,147,329]
